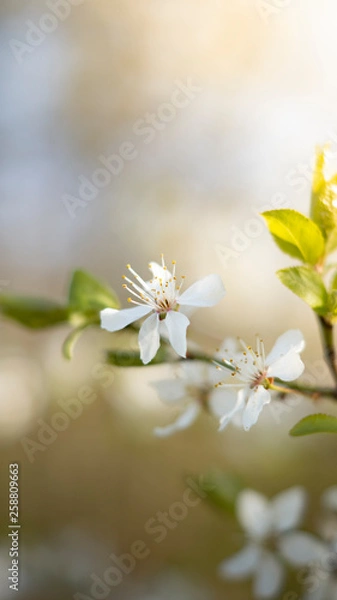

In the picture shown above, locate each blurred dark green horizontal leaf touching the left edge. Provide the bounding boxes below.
[0,296,68,329]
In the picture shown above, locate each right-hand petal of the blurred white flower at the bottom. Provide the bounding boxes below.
[278,531,327,567]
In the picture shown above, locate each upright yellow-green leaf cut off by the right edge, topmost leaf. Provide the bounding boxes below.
[311,148,337,253]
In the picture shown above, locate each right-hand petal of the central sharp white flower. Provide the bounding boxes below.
[177,275,226,306]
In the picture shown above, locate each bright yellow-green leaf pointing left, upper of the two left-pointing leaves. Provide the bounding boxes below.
[262,208,325,265]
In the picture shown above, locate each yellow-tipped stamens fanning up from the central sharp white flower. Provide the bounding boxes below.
[123,254,185,314]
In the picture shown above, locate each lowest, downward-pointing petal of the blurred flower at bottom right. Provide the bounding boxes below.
[254,551,285,600]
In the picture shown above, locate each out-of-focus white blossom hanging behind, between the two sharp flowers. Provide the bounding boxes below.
[151,361,228,437]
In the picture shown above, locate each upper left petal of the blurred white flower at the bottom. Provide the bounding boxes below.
[236,489,272,540]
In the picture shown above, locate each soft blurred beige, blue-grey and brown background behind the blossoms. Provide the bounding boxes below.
[0,0,337,600]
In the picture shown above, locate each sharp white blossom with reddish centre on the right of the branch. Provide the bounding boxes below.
[218,329,305,431]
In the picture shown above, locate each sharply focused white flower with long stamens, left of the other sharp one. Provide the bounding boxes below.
[101,256,225,364]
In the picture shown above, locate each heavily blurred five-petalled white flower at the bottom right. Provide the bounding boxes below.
[219,487,325,600]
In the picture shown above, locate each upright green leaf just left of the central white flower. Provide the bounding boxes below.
[69,271,120,314]
